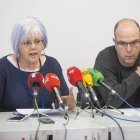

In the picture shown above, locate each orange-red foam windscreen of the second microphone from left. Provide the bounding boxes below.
[44,73,60,92]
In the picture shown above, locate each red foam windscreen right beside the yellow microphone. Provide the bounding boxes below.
[67,66,83,86]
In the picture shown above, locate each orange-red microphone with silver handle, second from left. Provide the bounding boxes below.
[44,73,64,109]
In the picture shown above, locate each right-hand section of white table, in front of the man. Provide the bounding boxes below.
[76,109,140,140]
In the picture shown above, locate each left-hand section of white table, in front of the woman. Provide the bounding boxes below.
[0,109,108,140]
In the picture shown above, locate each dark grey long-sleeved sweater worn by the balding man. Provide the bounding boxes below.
[94,46,140,108]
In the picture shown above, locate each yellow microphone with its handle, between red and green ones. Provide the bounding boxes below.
[81,69,100,108]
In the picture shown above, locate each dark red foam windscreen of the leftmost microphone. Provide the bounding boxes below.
[28,72,44,89]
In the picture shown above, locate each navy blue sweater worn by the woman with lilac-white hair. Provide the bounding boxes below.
[0,56,68,111]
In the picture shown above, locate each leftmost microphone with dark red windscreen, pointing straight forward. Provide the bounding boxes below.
[28,72,44,96]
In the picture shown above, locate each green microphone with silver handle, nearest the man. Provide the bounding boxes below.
[87,68,119,96]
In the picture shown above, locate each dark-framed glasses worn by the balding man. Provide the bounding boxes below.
[116,40,140,48]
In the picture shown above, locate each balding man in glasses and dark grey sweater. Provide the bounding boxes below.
[94,18,140,108]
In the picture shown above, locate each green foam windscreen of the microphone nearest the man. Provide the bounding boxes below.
[87,68,104,86]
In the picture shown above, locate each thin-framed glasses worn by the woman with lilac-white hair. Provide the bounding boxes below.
[22,39,42,47]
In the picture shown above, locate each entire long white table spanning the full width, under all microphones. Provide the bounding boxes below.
[0,109,140,140]
